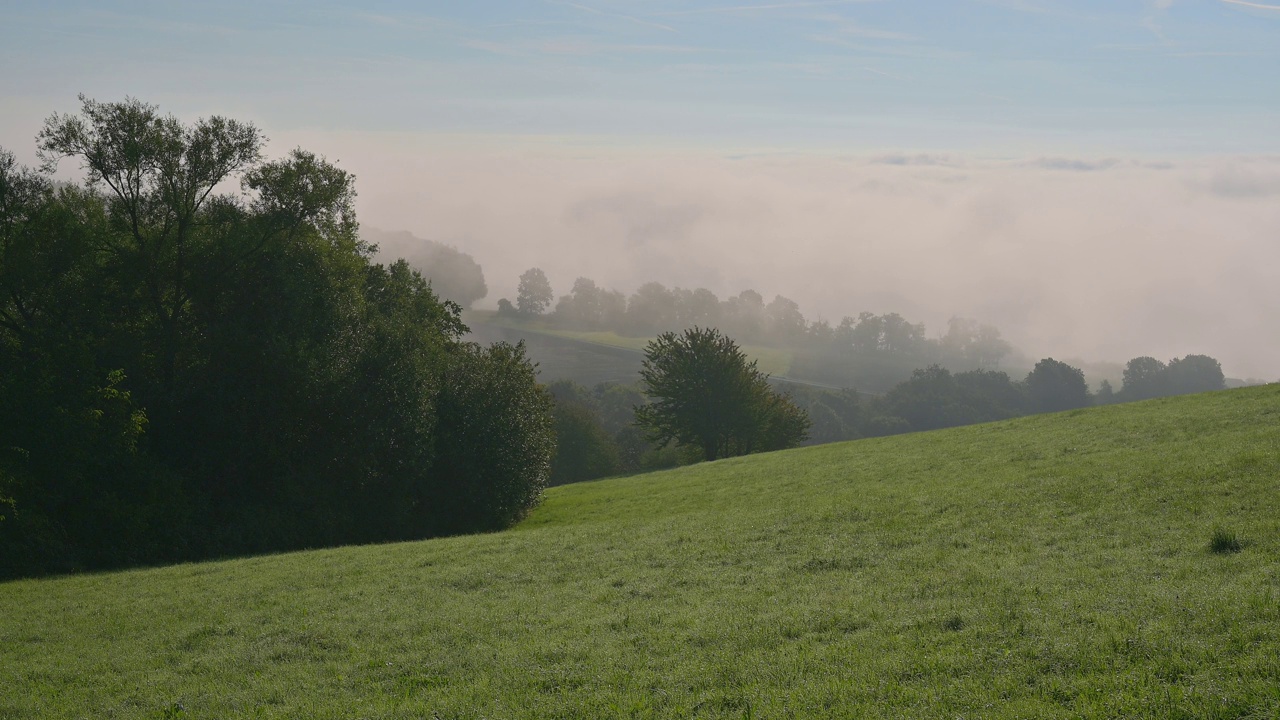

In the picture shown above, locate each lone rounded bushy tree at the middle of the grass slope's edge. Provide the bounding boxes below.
[636,328,810,460]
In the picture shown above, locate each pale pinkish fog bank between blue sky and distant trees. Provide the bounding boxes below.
[291,135,1280,379]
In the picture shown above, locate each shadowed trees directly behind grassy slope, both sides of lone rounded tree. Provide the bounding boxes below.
[552,355,1225,483]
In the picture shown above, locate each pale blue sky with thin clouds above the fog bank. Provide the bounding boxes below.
[0,0,1280,154]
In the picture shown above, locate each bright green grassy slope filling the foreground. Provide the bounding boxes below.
[0,386,1280,719]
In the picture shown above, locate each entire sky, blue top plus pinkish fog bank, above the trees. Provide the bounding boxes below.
[0,0,1280,379]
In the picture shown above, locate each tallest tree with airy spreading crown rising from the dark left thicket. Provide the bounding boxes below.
[36,95,263,391]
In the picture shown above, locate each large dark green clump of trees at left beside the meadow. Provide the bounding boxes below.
[0,97,554,577]
